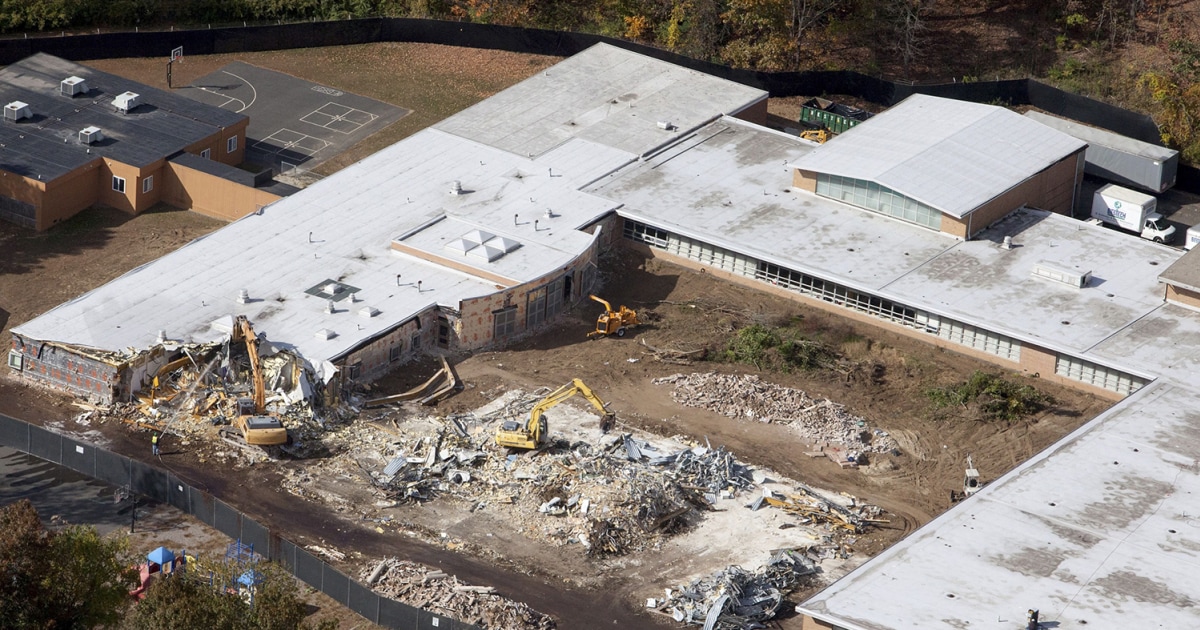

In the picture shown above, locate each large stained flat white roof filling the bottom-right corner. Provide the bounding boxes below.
[799,384,1200,630]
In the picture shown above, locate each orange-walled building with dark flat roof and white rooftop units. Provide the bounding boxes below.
[0,54,250,230]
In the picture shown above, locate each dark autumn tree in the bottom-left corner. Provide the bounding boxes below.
[0,500,137,629]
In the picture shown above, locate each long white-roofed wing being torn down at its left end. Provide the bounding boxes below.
[8,44,766,403]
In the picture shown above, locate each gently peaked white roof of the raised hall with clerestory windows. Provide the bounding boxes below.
[794,94,1087,217]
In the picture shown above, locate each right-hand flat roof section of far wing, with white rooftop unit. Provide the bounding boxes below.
[886,210,1183,350]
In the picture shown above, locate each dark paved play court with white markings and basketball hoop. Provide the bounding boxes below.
[180,61,410,173]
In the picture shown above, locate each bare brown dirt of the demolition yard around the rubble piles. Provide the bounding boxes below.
[0,248,1108,628]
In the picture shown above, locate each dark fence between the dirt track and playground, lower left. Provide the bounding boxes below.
[0,414,480,630]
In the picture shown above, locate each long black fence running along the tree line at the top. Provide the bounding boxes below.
[0,18,1200,187]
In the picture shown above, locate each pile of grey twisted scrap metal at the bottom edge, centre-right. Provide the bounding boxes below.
[647,550,816,630]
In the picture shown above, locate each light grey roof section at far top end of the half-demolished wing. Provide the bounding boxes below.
[434,43,767,157]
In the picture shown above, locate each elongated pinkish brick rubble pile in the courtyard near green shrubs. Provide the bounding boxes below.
[654,372,896,452]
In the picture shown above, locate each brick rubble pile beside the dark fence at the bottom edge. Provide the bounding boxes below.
[359,558,556,630]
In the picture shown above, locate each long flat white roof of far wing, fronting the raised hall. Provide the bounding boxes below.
[587,116,1183,357]
